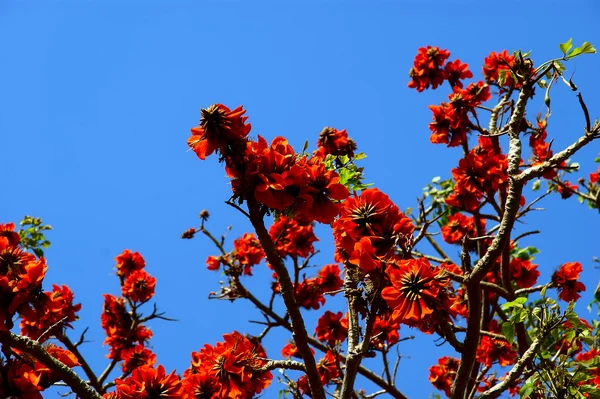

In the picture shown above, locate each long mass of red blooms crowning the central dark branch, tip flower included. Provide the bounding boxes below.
[188,104,348,224]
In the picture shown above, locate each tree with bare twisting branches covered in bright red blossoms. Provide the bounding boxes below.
[0,40,600,399]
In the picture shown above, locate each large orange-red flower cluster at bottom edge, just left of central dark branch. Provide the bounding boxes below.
[182,332,273,399]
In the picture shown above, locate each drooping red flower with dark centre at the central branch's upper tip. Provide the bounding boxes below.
[188,104,251,160]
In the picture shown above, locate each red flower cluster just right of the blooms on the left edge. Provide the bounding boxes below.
[21,285,81,341]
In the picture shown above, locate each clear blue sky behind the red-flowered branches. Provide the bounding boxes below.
[0,0,600,398]
